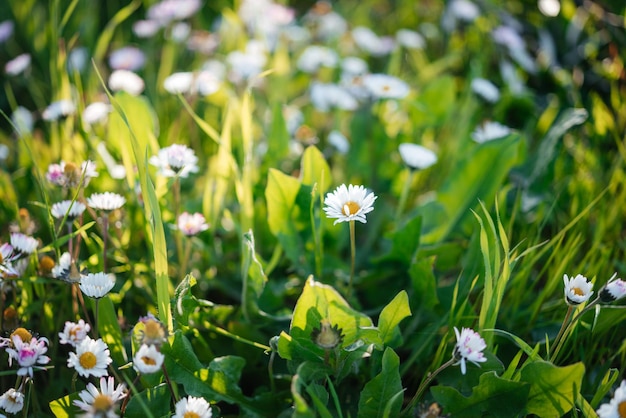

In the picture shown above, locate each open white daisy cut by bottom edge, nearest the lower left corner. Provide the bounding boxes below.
[74,376,126,418]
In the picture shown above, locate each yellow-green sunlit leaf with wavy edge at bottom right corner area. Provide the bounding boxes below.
[521,361,585,418]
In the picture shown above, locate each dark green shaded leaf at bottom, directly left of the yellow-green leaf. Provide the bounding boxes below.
[431,372,530,418]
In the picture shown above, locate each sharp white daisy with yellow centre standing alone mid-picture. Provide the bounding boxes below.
[324,184,378,225]
